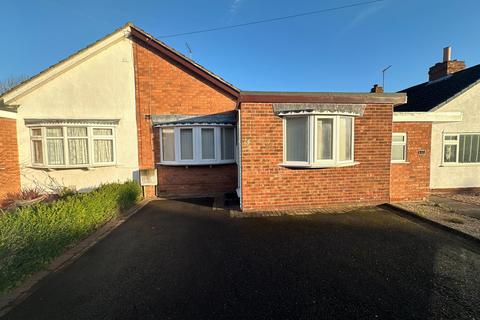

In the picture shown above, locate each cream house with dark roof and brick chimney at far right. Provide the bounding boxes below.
[395,48,480,191]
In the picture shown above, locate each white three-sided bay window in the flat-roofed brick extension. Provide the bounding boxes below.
[283,115,354,167]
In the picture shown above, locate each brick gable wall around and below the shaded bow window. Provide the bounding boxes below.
[133,43,237,195]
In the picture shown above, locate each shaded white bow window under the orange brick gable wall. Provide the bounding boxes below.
[160,125,236,165]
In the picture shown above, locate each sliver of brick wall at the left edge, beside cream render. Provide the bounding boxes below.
[0,118,20,206]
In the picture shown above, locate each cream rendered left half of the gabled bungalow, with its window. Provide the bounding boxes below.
[0,26,138,191]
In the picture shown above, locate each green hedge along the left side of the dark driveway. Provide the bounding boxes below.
[0,181,141,293]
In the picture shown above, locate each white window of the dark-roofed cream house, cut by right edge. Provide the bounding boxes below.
[442,133,480,165]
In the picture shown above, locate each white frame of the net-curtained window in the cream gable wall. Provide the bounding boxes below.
[28,124,117,169]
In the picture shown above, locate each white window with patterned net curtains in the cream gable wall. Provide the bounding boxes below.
[30,125,116,168]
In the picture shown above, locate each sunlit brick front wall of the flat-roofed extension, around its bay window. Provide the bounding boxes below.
[241,103,392,211]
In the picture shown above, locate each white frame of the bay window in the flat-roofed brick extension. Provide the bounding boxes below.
[281,113,356,168]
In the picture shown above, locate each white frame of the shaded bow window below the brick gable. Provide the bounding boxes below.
[157,124,238,166]
